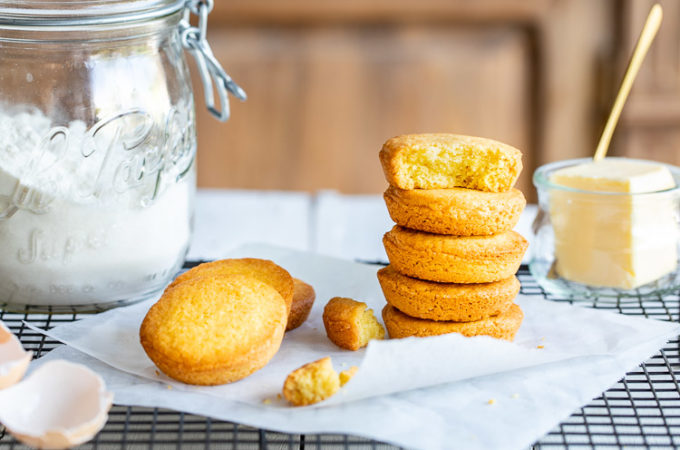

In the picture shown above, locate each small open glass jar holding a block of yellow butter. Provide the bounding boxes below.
[529,158,680,301]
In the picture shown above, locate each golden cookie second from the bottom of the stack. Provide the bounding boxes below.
[378,266,520,322]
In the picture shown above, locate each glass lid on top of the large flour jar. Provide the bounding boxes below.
[0,0,186,26]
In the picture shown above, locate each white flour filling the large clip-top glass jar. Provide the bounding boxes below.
[0,110,195,306]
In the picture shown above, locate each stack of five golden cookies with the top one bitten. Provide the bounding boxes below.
[378,134,528,340]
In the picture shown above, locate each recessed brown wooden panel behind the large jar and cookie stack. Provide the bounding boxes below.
[197,24,534,193]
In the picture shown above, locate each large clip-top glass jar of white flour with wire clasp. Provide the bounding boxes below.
[0,0,244,312]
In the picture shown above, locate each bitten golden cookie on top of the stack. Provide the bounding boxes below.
[380,133,522,192]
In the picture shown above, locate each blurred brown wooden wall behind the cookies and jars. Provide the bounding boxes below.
[191,0,680,200]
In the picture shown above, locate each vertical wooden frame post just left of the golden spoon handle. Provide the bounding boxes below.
[535,0,618,165]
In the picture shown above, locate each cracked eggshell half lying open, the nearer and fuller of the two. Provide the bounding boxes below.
[0,360,113,449]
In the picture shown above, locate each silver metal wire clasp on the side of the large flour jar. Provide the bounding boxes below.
[179,0,247,122]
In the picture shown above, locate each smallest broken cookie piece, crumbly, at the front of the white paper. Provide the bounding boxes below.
[283,356,340,406]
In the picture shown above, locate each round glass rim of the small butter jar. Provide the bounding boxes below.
[532,156,680,197]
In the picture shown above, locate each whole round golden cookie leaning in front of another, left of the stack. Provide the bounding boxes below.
[139,275,287,385]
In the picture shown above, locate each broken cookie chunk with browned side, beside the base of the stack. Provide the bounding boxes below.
[323,297,385,350]
